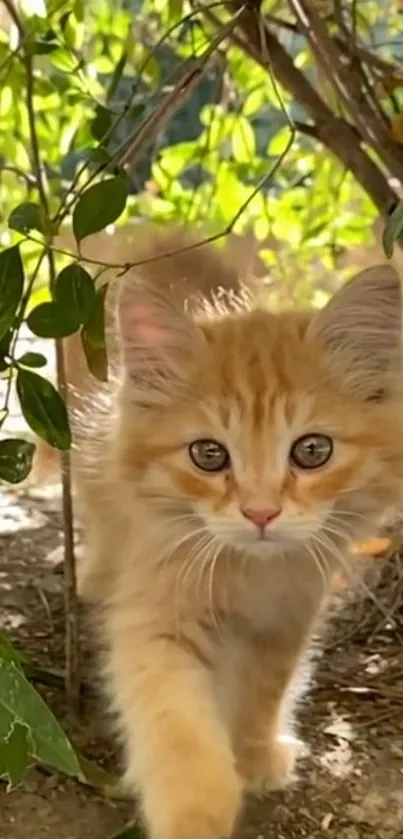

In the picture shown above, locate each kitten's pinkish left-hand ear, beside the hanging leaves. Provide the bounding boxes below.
[118,278,204,405]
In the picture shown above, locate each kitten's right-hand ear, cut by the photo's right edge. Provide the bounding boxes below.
[308,265,402,398]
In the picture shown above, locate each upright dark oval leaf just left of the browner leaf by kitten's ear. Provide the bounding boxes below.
[55,262,96,328]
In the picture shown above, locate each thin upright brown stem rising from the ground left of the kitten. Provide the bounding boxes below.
[11,0,80,714]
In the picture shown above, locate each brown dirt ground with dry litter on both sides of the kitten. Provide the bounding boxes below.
[0,486,403,839]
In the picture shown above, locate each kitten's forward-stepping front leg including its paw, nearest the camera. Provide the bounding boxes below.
[105,628,242,839]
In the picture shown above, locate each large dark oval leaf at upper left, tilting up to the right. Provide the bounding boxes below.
[73,175,128,242]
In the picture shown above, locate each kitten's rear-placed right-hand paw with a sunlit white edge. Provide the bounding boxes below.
[239,735,301,796]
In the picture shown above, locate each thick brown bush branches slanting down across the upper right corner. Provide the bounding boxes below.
[226,0,403,219]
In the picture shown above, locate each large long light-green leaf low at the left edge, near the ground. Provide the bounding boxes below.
[0,659,82,780]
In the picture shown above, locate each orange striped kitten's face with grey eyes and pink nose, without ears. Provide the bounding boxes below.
[119,266,403,554]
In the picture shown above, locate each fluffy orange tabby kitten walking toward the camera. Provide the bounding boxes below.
[76,228,403,839]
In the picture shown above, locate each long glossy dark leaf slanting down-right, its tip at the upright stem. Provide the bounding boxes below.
[16,370,71,451]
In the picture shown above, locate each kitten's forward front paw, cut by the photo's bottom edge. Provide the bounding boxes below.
[144,758,242,839]
